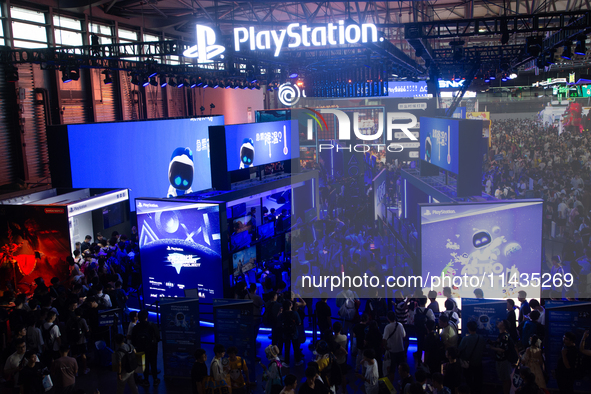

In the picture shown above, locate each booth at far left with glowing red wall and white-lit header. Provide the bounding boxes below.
[0,189,131,293]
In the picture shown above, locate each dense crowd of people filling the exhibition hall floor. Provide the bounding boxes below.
[0,120,591,394]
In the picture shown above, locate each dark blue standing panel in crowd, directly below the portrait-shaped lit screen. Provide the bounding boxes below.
[160,297,201,378]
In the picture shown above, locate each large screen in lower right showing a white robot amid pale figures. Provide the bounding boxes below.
[420,200,543,298]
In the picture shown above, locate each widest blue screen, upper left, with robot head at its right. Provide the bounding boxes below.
[68,116,224,209]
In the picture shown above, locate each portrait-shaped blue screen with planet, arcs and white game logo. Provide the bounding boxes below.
[136,199,223,307]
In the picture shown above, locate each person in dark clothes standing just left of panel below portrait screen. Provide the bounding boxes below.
[131,310,160,387]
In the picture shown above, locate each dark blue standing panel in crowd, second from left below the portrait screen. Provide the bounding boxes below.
[213,298,256,382]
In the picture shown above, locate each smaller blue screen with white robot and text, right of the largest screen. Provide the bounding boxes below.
[225,120,300,171]
